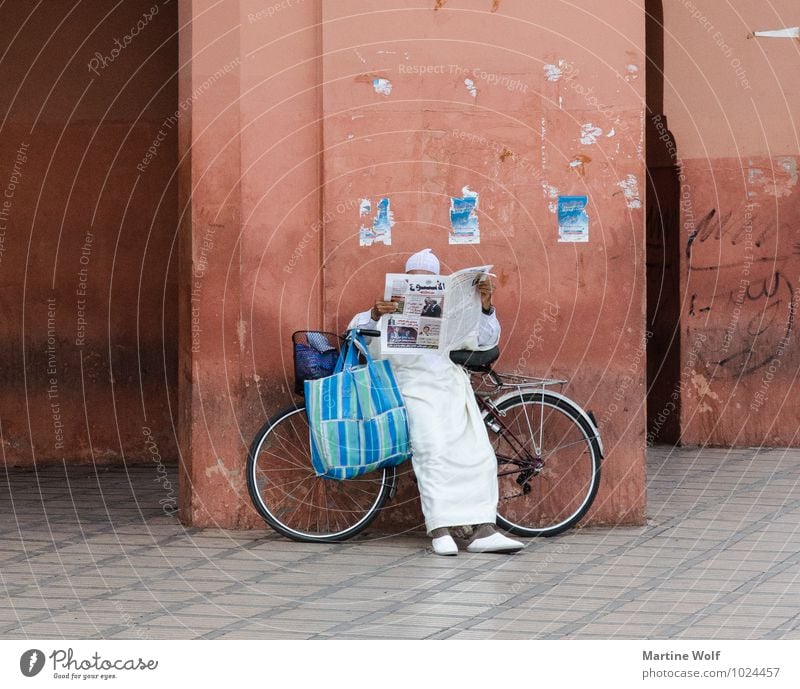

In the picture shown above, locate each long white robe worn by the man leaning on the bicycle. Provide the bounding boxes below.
[349,311,500,533]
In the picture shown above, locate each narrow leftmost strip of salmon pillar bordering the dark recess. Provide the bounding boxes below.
[178,0,244,526]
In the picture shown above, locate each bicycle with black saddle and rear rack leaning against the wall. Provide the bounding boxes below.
[247,329,603,543]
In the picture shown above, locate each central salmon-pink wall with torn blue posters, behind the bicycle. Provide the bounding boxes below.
[180,0,644,529]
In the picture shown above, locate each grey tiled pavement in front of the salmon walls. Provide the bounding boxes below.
[0,448,800,639]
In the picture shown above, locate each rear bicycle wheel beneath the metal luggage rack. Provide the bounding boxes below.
[485,391,601,536]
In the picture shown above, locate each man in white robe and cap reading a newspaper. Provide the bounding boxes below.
[350,249,522,555]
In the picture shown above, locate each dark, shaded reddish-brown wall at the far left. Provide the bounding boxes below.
[0,0,178,468]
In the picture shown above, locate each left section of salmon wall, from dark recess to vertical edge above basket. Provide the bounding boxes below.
[179,0,322,527]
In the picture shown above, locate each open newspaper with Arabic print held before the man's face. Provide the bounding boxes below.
[380,265,492,356]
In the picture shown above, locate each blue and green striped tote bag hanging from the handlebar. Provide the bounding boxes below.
[305,333,411,480]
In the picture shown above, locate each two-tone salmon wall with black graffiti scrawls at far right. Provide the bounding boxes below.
[664,0,800,446]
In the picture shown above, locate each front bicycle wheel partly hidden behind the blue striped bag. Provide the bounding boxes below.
[247,403,395,543]
